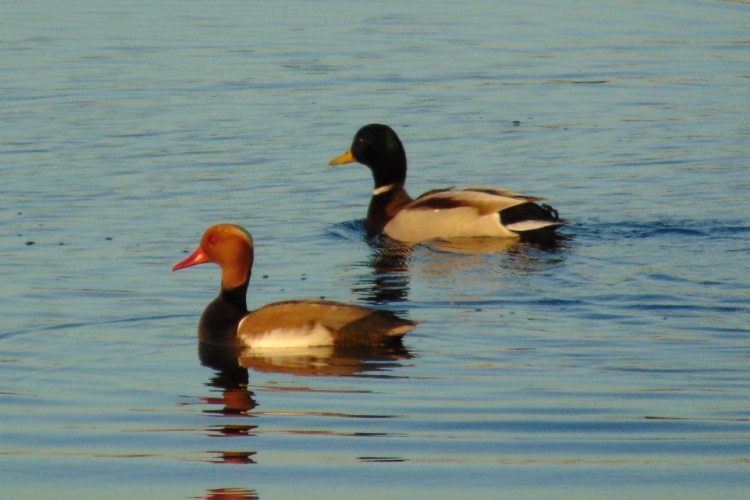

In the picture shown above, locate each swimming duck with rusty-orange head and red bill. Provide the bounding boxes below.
[172,224,417,350]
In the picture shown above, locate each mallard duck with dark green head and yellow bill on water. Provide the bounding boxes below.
[329,124,565,243]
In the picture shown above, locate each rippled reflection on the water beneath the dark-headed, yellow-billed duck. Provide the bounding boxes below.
[333,221,573,305]
